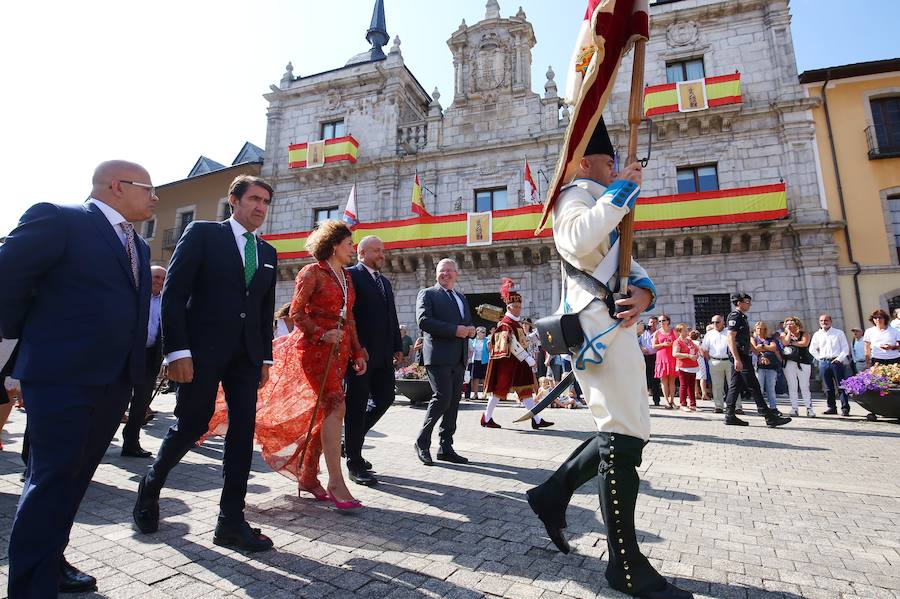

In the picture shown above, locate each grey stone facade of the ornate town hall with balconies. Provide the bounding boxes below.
[262,0,841,336]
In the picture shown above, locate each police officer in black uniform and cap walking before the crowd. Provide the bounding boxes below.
[725,292,791,428]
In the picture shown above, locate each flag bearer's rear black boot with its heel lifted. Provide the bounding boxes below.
[526,435,600,553]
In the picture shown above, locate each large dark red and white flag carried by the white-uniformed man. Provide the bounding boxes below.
[535,0,650,233]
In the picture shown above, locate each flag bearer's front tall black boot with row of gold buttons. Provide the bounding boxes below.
[598,433,693,599]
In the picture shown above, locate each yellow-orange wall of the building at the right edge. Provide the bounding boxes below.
[807,73,900,328]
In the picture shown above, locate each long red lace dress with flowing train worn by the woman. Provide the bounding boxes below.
[210,261,365,488]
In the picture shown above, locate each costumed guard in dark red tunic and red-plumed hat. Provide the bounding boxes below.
[481,278,553,429]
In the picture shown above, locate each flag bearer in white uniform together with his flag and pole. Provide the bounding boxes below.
[528,0,693,599]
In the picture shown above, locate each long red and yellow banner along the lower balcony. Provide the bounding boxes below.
[263,183,788,259]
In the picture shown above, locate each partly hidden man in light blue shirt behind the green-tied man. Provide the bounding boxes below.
[122,266,166,458]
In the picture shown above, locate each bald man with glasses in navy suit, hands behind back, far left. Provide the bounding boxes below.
[0,160,157,599]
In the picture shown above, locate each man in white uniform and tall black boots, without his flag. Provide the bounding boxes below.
[528,119,693,599]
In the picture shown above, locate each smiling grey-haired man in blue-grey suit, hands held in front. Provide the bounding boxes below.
[415,258,475,466]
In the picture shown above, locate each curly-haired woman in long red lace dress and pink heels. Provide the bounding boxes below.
[210,220,367,509]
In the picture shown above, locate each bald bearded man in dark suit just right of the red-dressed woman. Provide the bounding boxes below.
[344,235,403,485]
